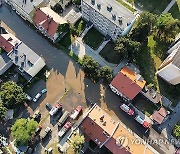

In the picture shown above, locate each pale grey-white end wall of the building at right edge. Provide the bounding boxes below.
[157,63,180,85]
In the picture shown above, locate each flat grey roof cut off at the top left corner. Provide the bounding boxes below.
[12,0,44,14]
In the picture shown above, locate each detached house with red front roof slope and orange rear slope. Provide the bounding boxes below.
[109,66,146,101]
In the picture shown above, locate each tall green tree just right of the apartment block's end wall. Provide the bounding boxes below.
[130,12,157,43]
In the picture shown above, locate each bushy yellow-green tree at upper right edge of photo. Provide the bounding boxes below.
[154,13,180,43]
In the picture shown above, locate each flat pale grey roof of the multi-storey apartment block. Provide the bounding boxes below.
[83,0,135,29]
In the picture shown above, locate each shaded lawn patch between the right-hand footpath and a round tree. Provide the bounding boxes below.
[99,41,121,64]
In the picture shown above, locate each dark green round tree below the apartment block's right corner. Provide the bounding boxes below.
[114,37,141,61]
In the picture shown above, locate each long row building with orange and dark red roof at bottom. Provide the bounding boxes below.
[79,104,158,154]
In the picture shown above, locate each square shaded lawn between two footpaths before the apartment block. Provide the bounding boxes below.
[83,28,104,50]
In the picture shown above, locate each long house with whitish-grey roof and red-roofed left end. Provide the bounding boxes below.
[0,33,45,81]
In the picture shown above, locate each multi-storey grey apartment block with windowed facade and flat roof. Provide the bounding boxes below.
[81,0,136,41]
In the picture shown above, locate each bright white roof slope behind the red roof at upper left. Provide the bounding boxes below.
[40,7,67,24]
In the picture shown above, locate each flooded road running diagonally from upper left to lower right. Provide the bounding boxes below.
[0,2,176,153]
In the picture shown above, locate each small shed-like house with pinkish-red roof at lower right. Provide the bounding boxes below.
[152,107,168,124]
